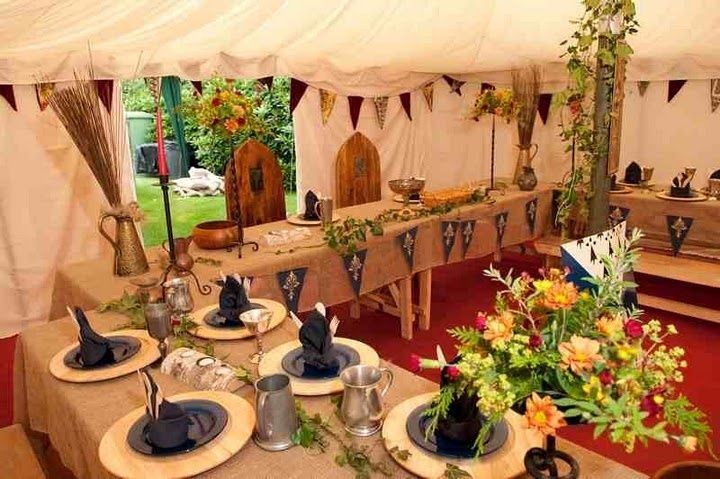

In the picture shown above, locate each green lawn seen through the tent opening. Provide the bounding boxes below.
[135,175,297,246]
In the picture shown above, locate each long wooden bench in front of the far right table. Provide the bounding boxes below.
[535,236,720,323]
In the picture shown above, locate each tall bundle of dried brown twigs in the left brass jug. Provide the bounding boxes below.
[48,71,123,209]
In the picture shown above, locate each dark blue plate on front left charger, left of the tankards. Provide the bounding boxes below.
[127,399,228,457]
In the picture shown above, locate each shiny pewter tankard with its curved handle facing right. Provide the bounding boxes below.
[340,364,393,436]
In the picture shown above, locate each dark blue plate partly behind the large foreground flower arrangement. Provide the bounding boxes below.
[406,404,508,459]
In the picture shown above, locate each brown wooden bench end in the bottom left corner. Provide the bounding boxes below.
[0,424,45,479]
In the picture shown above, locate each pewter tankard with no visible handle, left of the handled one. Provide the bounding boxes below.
[253,374,298,451]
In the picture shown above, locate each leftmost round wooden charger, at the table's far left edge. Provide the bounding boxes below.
[49,329,160,383]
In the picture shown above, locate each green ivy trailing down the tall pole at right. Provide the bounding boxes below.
[554,0,638,229]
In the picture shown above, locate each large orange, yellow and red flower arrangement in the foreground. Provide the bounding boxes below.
[411,230,713,460]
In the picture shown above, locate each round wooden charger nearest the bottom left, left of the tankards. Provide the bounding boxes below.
[98,391,255,479]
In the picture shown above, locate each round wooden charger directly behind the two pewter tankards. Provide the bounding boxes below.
[258,338,380,396]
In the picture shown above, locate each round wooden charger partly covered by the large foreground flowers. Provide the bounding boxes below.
[382,393,543,479]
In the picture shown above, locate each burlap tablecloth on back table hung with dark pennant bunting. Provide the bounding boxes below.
[50,184,552,319]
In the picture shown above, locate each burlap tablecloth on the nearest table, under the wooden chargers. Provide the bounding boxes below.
[20,312,646,479]
